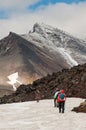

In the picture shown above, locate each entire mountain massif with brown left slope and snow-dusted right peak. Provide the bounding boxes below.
[0,23,86,94]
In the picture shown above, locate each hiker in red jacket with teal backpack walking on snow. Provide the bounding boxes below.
[57,90,66,113]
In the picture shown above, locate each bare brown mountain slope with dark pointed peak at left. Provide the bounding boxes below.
[0,32,68,91]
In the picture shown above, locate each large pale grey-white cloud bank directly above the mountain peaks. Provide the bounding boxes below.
[0,0,86,38]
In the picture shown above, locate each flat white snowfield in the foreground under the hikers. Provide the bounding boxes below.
[0,98,86,130]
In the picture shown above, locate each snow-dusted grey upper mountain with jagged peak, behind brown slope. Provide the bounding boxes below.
[22,23,86,67]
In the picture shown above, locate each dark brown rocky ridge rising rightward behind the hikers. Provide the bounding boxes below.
[0,64,86,103]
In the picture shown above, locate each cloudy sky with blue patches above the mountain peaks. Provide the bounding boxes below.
[0,0,86,39]
